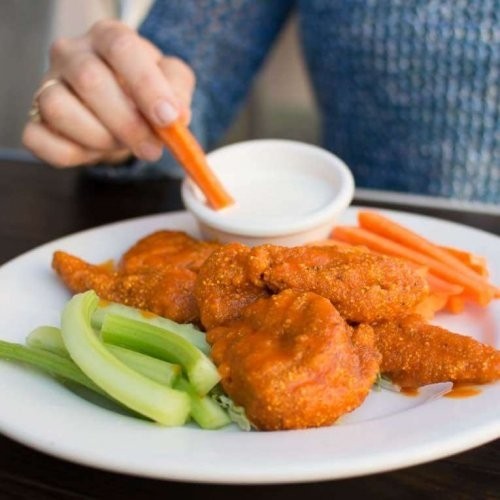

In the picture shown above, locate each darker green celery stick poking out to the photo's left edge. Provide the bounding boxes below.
[0,340,106,395]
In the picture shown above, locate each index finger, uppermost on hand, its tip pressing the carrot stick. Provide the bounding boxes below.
[92,22,179,126]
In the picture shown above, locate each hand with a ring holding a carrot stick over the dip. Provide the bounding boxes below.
[23,20,195,167]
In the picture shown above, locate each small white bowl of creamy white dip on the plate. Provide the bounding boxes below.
[181,139,354,246]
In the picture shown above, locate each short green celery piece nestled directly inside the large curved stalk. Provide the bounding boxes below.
[104,343,181,387]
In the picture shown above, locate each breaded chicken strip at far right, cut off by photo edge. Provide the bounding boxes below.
[372,315,500,388]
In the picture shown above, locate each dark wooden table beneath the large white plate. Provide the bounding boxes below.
[0,160,500,500]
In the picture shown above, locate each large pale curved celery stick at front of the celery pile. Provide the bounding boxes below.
[61,290,191,426]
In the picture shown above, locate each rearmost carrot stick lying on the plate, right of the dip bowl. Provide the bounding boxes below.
[358,211,490,288]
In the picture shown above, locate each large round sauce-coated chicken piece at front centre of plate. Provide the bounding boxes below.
[207,290,380,430]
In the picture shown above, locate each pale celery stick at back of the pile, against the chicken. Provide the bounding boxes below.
[92,301,210,354]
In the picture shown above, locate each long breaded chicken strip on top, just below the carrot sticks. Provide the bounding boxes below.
[252,245,429,323]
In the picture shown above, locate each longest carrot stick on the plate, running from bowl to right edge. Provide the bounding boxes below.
[332,226,495,306]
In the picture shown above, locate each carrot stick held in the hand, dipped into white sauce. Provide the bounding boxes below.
[156,120,234,210]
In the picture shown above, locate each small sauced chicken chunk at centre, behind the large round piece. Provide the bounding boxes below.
[194,243,269,329]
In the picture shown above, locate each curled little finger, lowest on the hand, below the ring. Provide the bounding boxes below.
[23,122,102,168]
